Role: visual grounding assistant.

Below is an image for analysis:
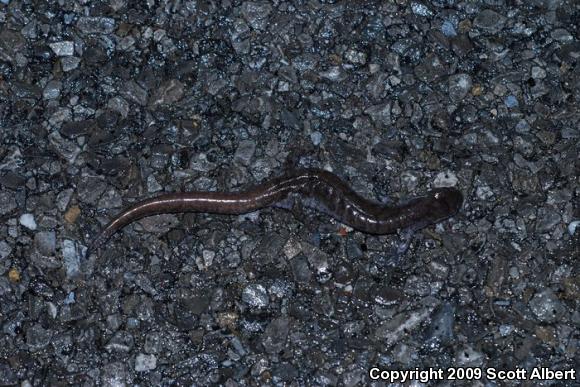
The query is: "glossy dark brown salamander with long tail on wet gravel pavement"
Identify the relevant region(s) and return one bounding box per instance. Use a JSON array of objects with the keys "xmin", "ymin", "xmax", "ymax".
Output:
[{"xmin": 87, "ymin": 169, "xmax": 463, "ymax": 256}]
